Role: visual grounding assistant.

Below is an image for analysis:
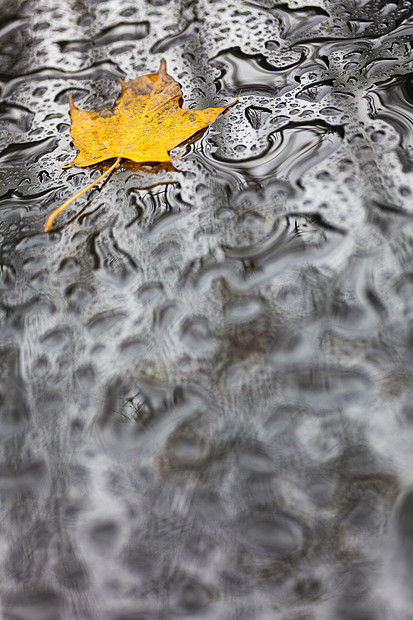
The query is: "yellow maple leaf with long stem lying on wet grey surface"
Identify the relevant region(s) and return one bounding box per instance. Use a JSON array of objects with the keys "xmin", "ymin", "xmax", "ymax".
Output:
[{"xmin": 44, "ymin": 59, "xmax": 236, "ymax": 232}]
